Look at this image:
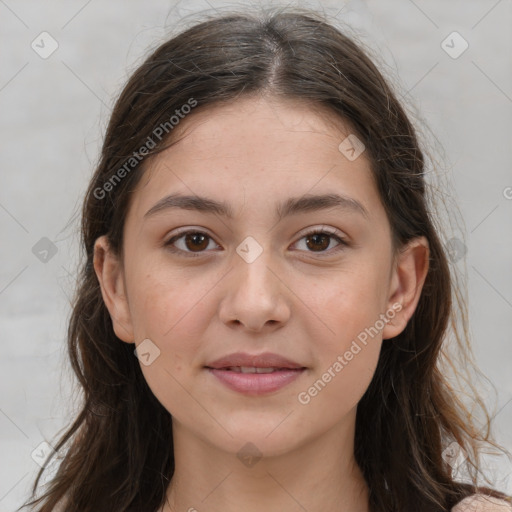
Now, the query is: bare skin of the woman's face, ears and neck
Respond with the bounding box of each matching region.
[95,97,428,512]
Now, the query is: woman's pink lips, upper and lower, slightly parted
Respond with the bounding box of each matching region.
[205,352,306,395]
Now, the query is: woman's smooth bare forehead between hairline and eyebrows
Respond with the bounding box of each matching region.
[128,97,379,224]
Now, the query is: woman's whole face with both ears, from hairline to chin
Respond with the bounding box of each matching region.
[95,94,426,455]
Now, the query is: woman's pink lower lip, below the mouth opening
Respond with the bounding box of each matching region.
[208,368,305,395]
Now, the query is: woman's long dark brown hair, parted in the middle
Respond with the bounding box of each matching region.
[20,9,503,512]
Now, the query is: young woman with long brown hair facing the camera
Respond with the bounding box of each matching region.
[21,5,512,512]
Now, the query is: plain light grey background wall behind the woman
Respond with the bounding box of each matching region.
[0,0,512,511]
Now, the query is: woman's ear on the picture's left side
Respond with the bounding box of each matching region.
[94,235,134,343]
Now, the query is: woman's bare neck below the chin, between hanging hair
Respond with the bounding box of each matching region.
[162,411,369,512]
